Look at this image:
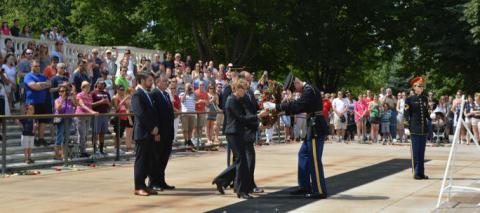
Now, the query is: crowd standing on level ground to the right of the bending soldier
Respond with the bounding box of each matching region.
[324,88,480,145]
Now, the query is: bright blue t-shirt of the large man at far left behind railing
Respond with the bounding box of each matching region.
[23,72,48,104]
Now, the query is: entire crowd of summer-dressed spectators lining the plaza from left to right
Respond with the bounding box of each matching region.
[0,20,480,163]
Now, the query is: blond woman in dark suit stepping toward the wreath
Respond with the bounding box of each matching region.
[224,79,268,199]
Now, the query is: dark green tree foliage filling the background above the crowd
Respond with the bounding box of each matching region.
[0,0,480,93]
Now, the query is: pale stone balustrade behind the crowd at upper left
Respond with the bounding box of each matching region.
[0,36,164,70]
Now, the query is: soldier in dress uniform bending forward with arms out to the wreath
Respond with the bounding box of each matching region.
[264,73,328,199]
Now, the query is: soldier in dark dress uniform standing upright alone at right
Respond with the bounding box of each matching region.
[404,76,430,180]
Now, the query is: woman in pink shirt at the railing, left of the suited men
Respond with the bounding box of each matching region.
[75,81,98,157]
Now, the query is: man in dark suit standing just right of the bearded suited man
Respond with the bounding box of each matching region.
[150,74,175,191]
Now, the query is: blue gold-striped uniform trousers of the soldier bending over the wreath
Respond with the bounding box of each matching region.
[298,134,327,194]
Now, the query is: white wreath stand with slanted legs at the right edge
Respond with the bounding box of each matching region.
[437,96,480,208]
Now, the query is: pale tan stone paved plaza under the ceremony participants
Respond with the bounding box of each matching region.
[0,144,480,213]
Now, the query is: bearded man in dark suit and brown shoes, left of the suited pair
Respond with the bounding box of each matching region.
[132,72,158,196]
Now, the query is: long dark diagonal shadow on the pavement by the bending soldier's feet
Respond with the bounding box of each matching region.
[208,159,412,212]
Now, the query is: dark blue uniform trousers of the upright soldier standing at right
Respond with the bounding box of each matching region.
[412,134,427,176]
